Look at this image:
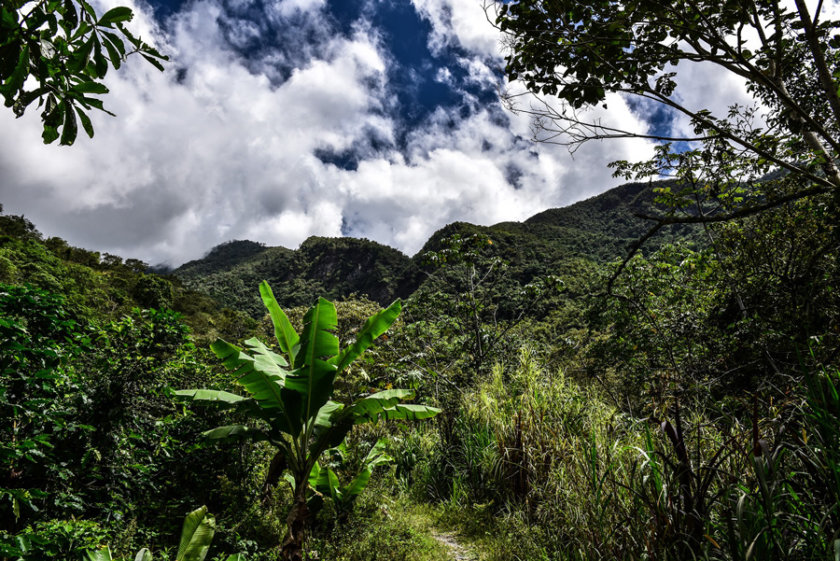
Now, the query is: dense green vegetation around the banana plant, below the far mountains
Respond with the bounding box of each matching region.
[0,165,840,560]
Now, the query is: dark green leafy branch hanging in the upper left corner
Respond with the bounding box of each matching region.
[0,0,169,145]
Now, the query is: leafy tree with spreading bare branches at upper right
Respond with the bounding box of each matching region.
[488,0,840,230]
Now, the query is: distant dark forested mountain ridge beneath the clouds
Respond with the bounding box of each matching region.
[172,183,696,317]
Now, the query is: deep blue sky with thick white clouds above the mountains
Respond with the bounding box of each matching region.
[0,0,756,266]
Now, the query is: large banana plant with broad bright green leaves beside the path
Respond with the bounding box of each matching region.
[175,281,440,561]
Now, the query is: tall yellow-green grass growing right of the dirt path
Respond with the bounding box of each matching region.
[412,350,840,561]
